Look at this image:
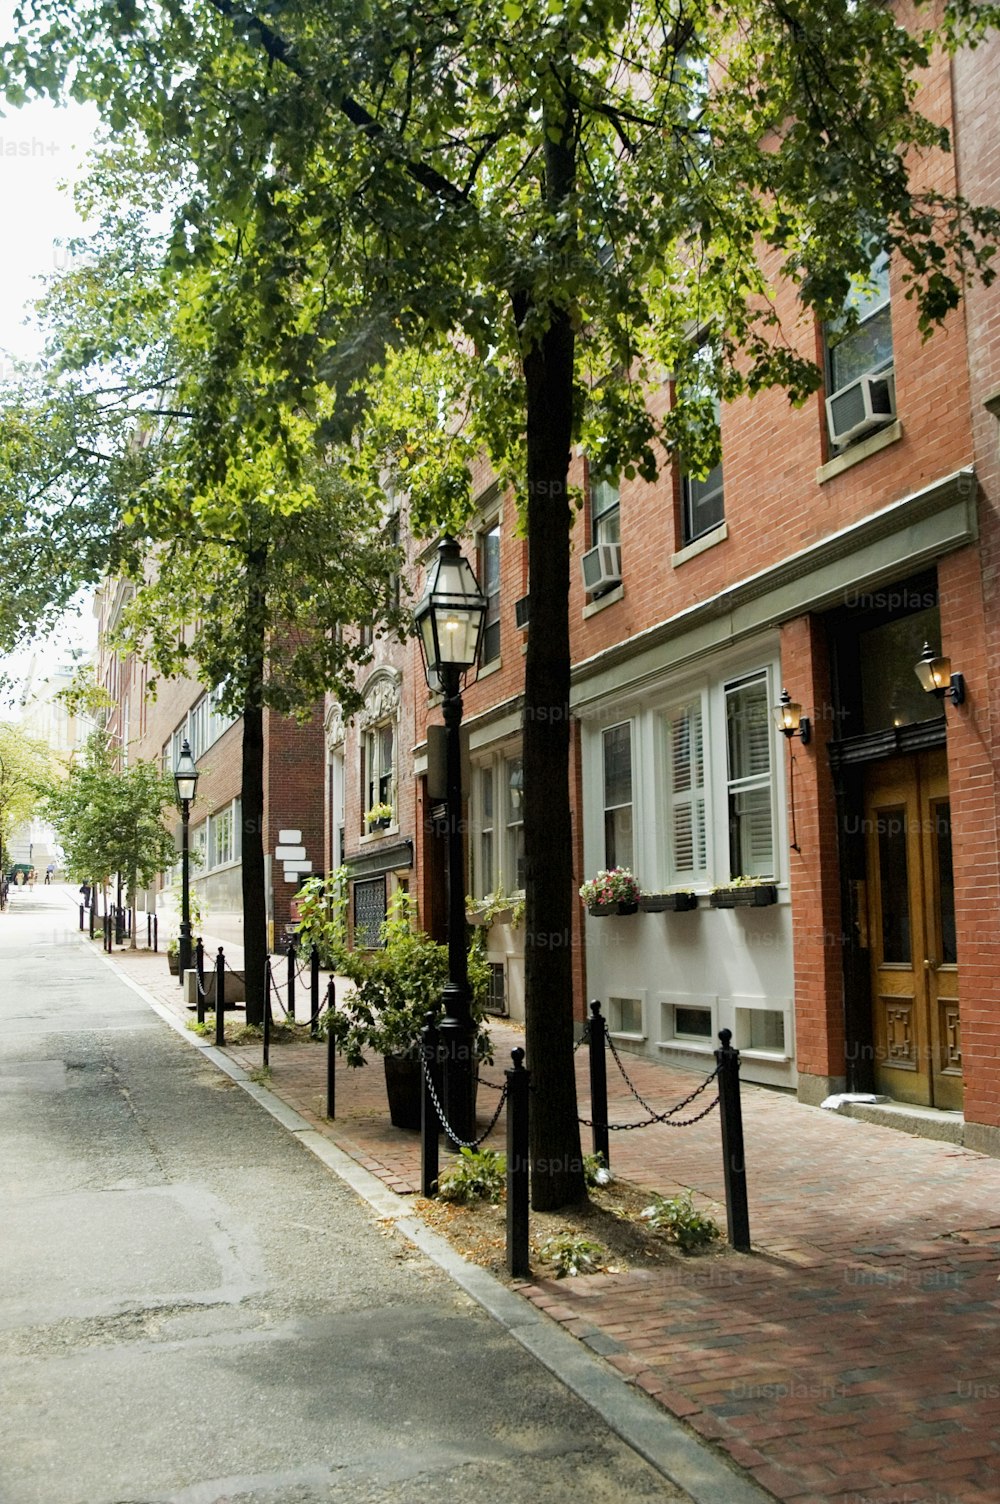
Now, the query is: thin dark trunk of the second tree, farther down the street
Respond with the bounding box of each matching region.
[242,547,268,1024]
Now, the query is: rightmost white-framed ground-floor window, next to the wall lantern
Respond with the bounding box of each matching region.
[725,674,774,877]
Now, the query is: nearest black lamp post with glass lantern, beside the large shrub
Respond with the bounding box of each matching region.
[414,535,487,1142]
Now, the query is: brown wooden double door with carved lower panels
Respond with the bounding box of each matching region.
[865,750,962,1110]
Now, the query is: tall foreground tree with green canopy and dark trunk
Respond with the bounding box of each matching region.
[3,0,998,1208]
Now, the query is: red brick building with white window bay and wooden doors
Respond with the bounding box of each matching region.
[328,23,1000,1152]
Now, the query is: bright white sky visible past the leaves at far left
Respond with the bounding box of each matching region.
[0,17,96,719]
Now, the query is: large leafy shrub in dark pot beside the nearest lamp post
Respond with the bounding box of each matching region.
[320,893,492,1128]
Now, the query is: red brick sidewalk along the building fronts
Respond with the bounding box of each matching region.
[103,920,1000,1504]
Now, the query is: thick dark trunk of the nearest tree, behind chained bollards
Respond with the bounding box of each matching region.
[514,103,586,1211]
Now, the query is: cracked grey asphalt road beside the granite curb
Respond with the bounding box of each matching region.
[0,886,687,1504]
